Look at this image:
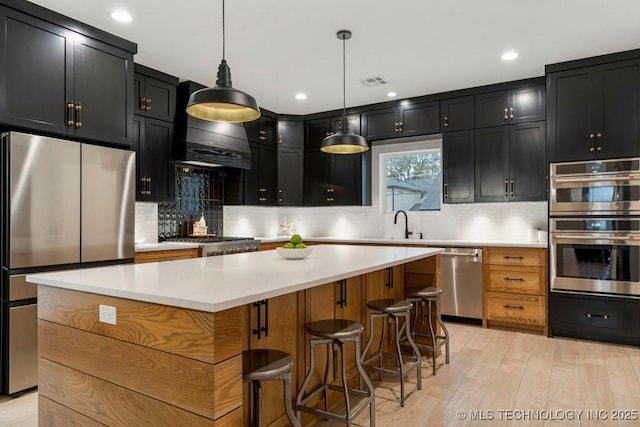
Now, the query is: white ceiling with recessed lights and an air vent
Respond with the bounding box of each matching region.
[32,0,640,114]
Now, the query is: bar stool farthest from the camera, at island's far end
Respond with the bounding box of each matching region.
[407,287,449,375]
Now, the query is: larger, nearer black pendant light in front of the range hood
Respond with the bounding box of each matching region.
[186,0,260,123]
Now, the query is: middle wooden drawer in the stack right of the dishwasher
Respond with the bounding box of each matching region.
[485,265,547,295]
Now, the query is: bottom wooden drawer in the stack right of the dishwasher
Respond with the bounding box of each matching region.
[485,292,546,326]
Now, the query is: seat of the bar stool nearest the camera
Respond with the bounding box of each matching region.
[242,349,293,382]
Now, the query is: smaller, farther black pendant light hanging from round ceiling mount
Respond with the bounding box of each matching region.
[320,30,369,154]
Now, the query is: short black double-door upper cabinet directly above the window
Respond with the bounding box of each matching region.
[362,101,440,141]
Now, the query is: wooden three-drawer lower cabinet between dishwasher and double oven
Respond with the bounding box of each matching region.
[482,248,547,334]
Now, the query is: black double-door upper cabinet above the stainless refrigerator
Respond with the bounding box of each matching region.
[0,7,137,145]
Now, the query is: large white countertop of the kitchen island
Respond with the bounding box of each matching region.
[27,245,442,312]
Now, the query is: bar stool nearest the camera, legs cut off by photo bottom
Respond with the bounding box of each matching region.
[242,349,301,427]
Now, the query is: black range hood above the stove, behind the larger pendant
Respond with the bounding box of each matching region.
[173,81,251,169]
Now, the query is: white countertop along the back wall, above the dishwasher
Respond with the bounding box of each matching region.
[255,236,549,248]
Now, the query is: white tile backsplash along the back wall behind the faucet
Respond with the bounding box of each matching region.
[224,202,547,241]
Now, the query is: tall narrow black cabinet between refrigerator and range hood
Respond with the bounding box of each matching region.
[133,64,178,202]
